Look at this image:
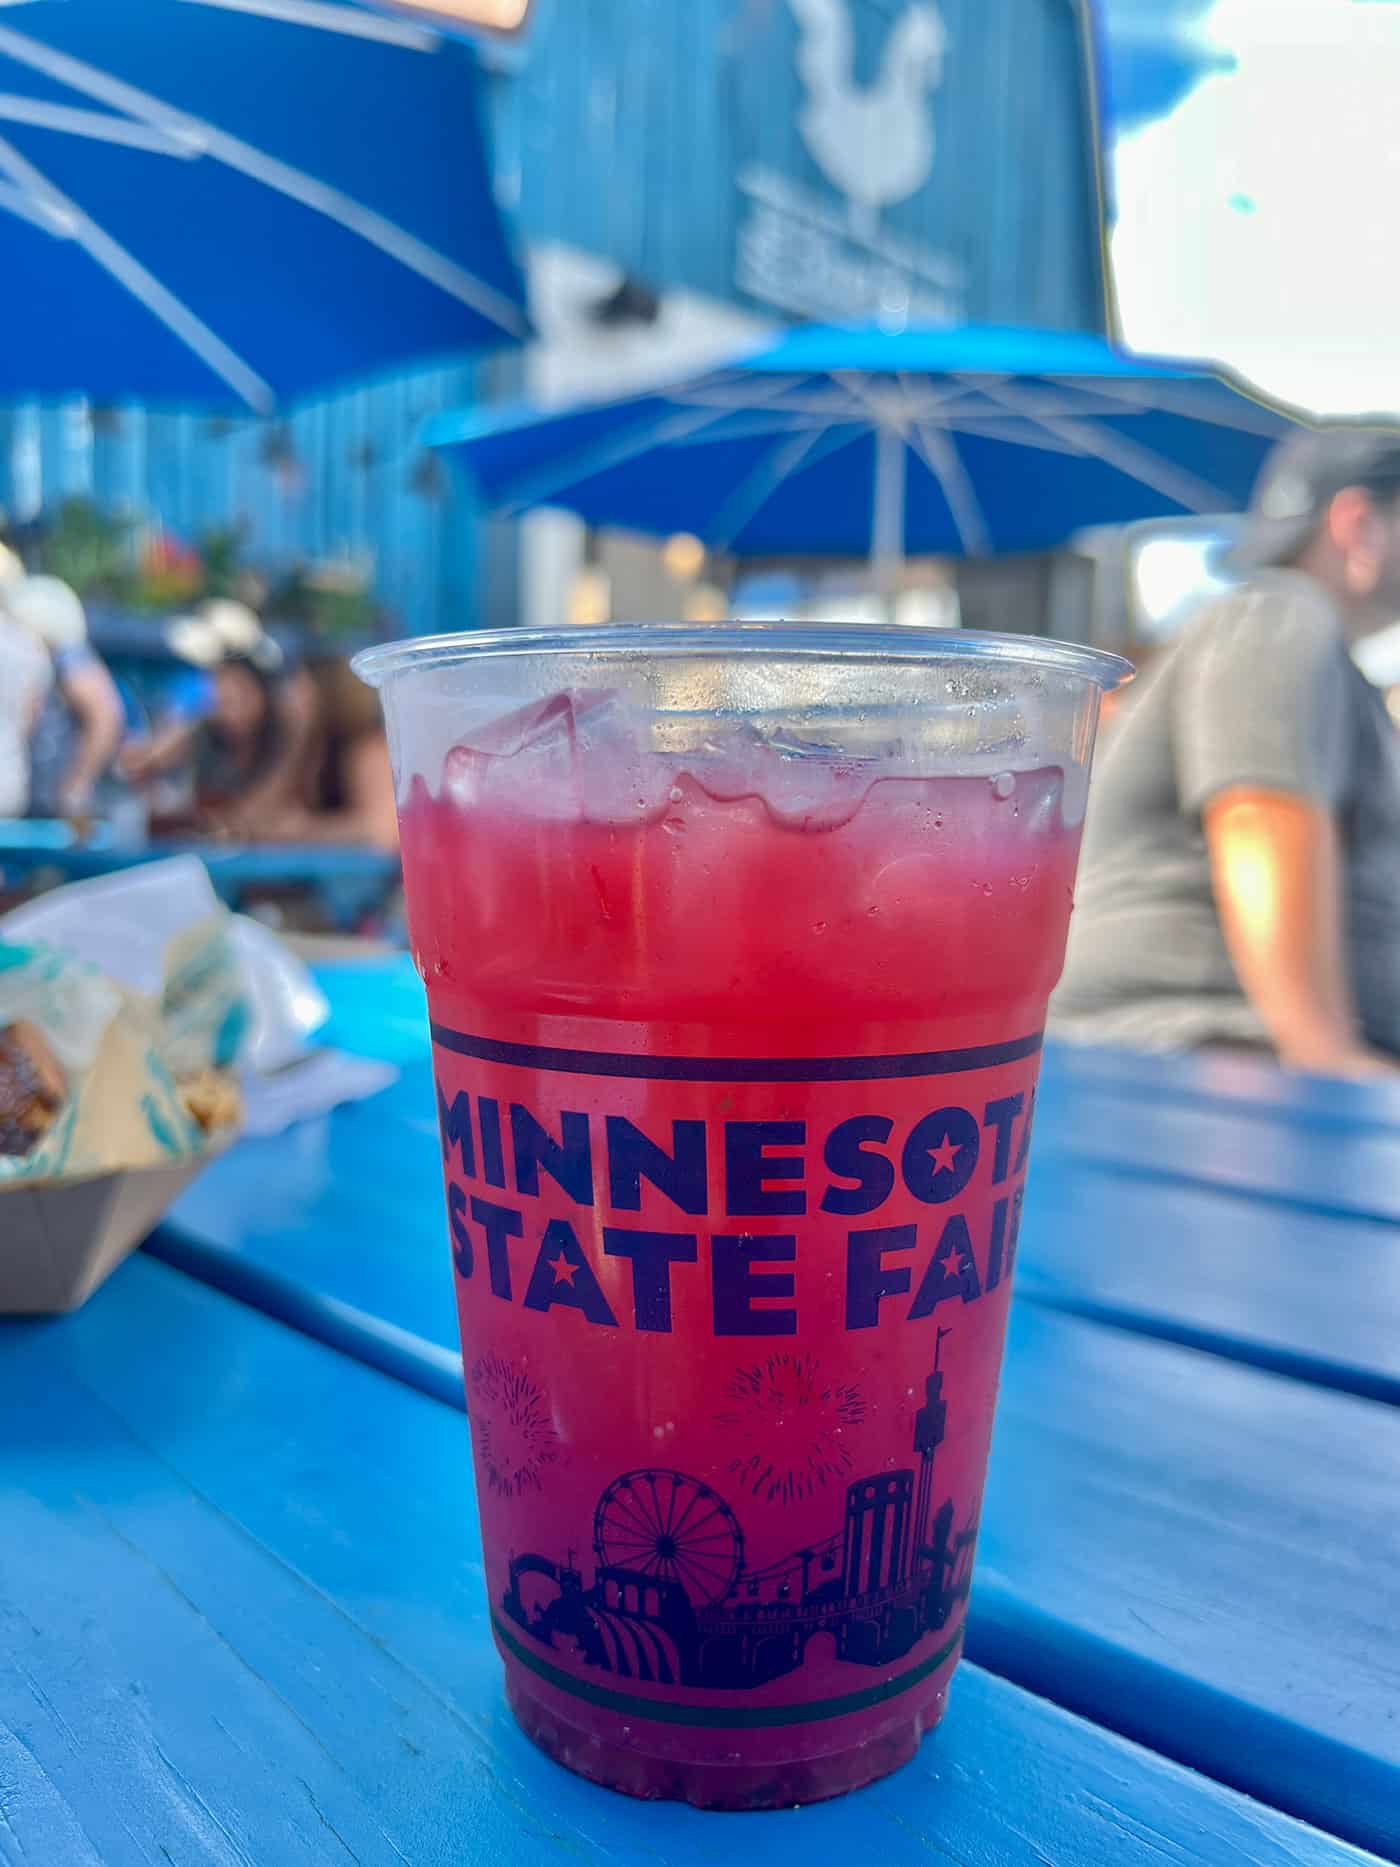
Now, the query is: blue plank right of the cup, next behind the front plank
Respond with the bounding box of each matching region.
[969,1303,1400,1860]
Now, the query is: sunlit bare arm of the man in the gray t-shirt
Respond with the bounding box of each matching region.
[1204,786,1394,1075]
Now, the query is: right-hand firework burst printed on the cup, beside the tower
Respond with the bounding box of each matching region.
[715,1350,866,1505]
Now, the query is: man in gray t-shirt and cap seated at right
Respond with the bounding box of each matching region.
[1051,426,1400,1075]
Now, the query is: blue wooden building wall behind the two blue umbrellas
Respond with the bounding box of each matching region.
[0,0,1105,633]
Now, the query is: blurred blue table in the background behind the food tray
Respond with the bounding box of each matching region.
[0,820,399,930]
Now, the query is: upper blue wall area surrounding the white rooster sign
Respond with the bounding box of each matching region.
[495,0,1105,330]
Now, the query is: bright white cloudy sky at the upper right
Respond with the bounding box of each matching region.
[1109,0,1400,414]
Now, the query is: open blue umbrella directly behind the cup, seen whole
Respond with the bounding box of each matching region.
[427,327,1292,573]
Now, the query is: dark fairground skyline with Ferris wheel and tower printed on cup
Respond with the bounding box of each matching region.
[502,1354,976,1690]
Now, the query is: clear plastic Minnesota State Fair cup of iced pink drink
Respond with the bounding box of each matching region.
[357,624,1127,1807]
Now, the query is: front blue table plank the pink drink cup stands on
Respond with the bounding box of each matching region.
[0,1258,1388,1867]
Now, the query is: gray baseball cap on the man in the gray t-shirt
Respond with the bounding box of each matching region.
[1228,422,1400,569]
